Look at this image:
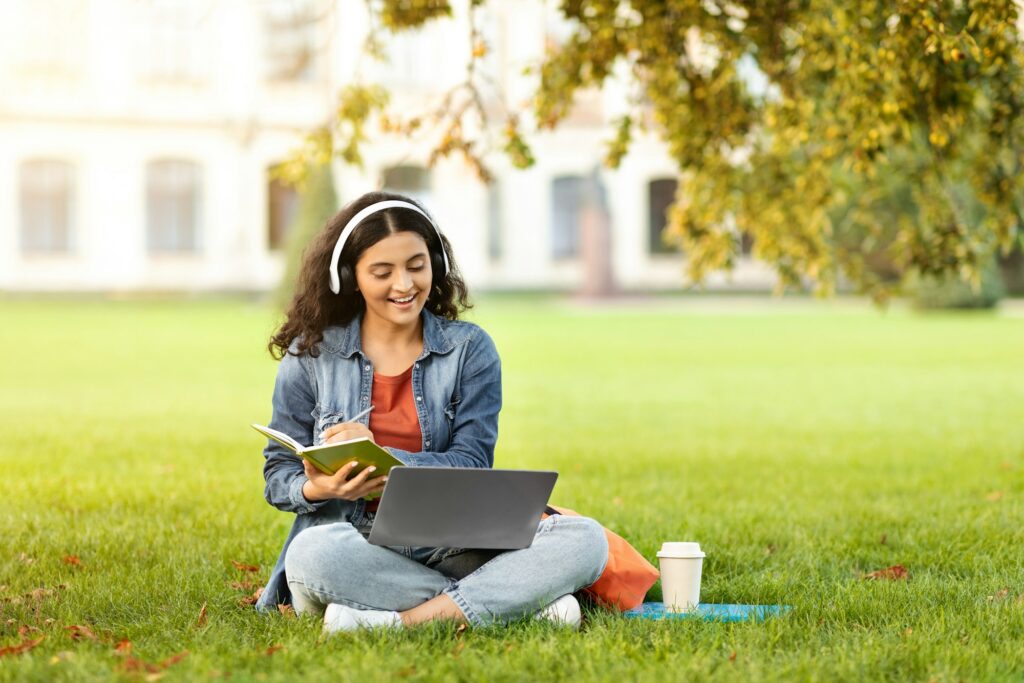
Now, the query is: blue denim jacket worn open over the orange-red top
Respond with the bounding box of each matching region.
[256,308,502,611]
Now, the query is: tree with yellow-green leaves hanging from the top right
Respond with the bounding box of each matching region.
[282,0,1024,300]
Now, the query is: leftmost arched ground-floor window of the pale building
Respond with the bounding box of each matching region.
[18,160,75,254]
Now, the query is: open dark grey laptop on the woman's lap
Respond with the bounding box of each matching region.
[368,467,558,550]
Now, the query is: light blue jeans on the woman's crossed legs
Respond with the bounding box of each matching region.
[285,505,608,626]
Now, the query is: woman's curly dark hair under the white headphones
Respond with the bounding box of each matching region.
[267,187,472,359]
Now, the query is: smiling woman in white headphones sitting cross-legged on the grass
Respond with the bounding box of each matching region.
[256,193,607,632]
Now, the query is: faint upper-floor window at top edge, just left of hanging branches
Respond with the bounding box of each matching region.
[263,0,328,81]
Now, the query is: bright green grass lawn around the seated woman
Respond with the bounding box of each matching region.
[0,298,1024,681]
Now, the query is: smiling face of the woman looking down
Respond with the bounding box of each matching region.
[355,230,433,326]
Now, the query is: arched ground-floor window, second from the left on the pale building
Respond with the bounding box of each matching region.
[145,160,202,253]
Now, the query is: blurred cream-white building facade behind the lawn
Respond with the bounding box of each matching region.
[0,0,773,291]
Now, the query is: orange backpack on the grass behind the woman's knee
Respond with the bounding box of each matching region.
[541,505,659,611]
